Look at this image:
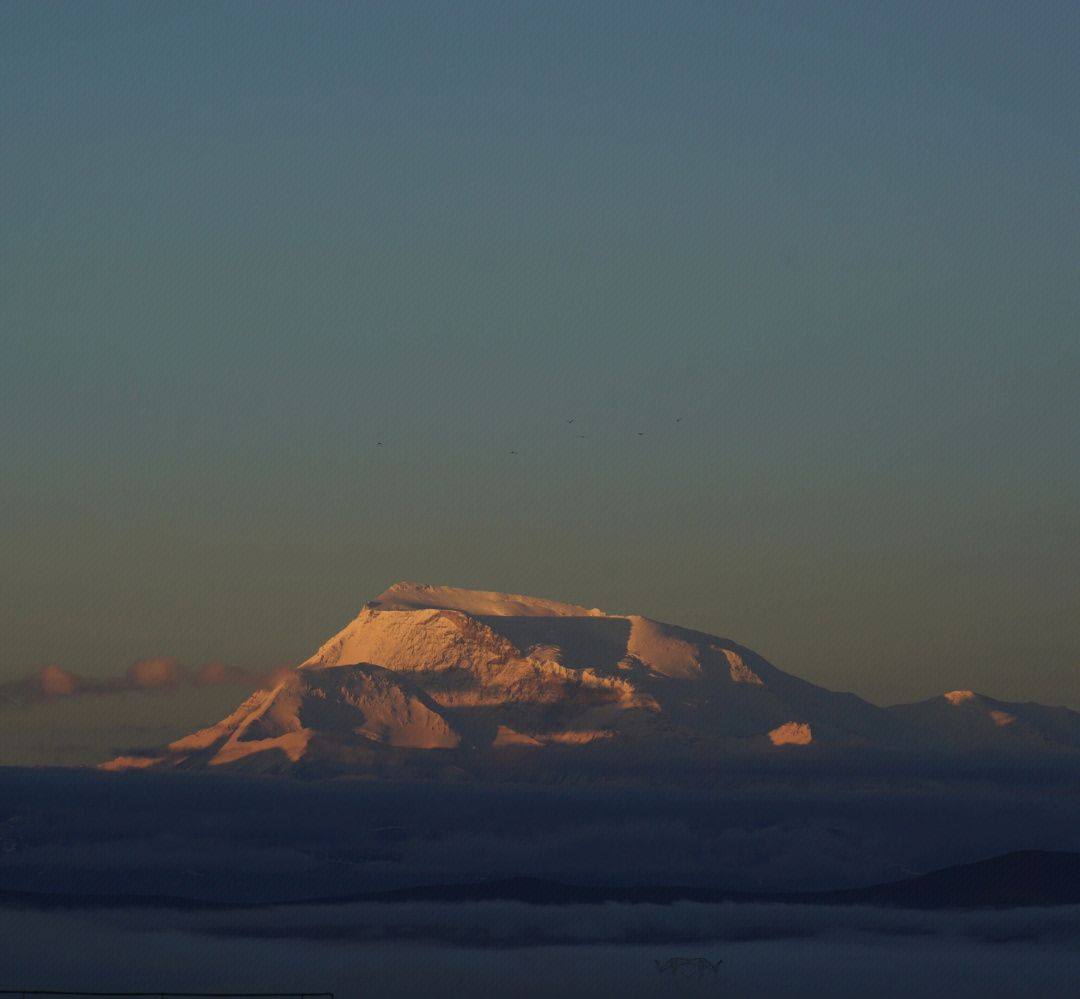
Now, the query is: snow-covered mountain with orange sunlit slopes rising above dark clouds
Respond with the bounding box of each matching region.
[103,583,1080,777]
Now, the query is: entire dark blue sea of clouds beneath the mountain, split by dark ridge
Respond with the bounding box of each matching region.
[6,760,1080,999]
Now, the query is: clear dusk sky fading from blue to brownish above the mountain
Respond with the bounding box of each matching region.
[0,0,1080,725]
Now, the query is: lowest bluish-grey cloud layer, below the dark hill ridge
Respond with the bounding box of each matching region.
[0,904,1080,999]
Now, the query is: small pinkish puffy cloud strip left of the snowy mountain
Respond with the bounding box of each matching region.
[0,656,293,706]
